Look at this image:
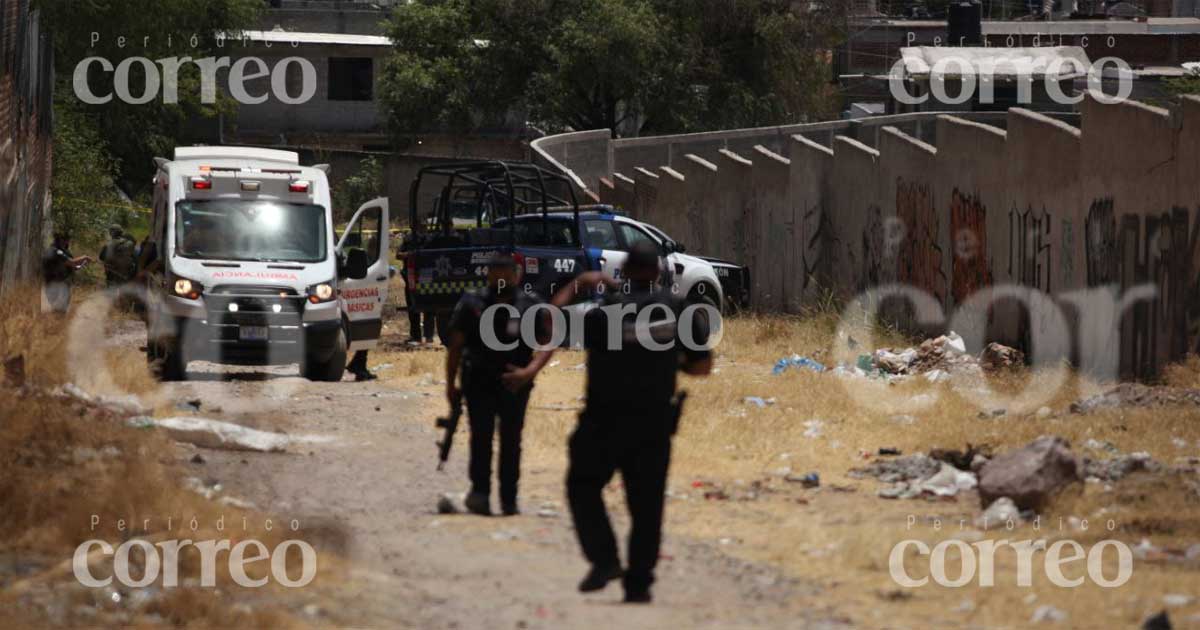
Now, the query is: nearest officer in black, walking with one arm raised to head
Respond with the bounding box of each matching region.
[552,241,713,602]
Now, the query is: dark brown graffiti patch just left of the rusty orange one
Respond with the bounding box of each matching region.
[902,178,946,302]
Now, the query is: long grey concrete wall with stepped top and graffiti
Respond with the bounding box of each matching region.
[540,97,1200,378]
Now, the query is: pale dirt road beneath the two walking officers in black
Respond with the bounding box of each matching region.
[152,350,839,628]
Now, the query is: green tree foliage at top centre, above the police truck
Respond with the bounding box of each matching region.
[382,0,840,134]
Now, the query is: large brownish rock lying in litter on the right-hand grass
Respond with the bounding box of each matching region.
[979,436,1082,510]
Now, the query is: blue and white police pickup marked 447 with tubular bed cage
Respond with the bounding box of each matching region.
[401,162,748,338]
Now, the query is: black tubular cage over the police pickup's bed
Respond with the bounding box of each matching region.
[408,160,580,245]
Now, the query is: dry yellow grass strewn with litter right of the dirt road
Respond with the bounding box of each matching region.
[379,313,1200,628]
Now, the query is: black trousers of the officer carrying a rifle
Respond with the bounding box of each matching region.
[466,379,532,505]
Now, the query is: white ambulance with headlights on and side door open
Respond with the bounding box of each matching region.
[138,146,389,380]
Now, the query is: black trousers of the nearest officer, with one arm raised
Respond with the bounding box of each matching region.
[566,410,671,592]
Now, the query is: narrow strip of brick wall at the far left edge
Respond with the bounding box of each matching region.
[0,0,54,292]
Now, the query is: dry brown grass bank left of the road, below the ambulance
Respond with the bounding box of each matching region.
[0,283,355,628]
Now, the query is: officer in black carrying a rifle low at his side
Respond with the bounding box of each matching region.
[446,253,552,516]
